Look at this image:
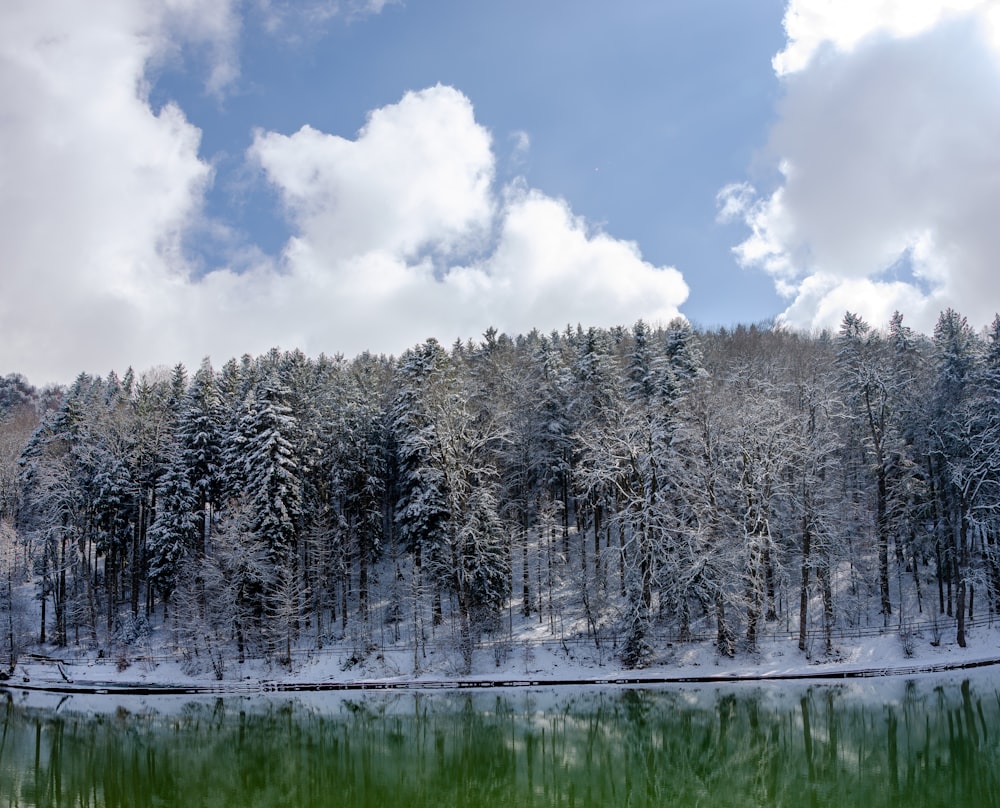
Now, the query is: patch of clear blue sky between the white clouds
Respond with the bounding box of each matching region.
[152,0,784,326]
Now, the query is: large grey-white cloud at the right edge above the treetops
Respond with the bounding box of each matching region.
[719,0,1000,330]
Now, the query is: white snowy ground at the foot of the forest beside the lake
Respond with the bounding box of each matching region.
[6,621,1000,693]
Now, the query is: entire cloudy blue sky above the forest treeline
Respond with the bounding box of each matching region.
[0,0,1000,384]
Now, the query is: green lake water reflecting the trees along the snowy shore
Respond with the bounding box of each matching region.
[0,674,1000,808]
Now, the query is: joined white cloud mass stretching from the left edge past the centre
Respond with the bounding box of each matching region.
[0,0,687,383]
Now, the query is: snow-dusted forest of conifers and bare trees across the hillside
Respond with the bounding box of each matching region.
[0,310,1000,678]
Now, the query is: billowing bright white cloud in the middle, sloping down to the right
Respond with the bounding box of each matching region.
[251,86,687,352]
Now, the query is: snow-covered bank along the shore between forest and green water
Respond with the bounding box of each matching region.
[0,625,1000,695]
